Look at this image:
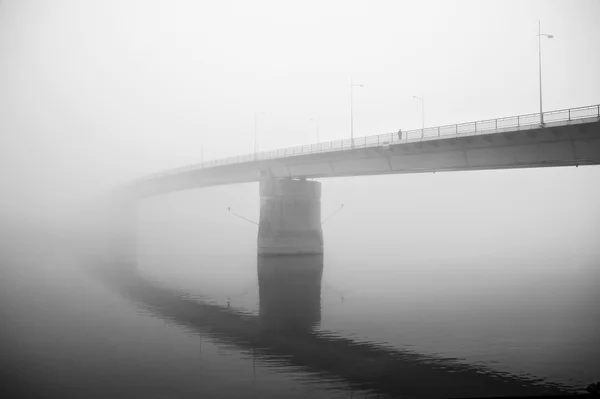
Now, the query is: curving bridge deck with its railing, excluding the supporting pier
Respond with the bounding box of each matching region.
[126,105,600,198]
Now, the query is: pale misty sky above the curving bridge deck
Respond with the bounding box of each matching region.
[0,0,600,225]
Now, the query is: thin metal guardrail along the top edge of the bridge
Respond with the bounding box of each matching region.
[138,104,600,181]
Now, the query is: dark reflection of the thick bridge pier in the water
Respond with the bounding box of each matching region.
[258,254,323,331]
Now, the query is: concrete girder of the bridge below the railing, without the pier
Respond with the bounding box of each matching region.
[131,118,600,198]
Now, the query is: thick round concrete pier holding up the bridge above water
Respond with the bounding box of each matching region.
[258,178,323,256]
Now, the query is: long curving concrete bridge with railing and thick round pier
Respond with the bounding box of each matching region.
[114,105,600,256]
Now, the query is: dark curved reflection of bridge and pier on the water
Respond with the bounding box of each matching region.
[88,256,570,398]
